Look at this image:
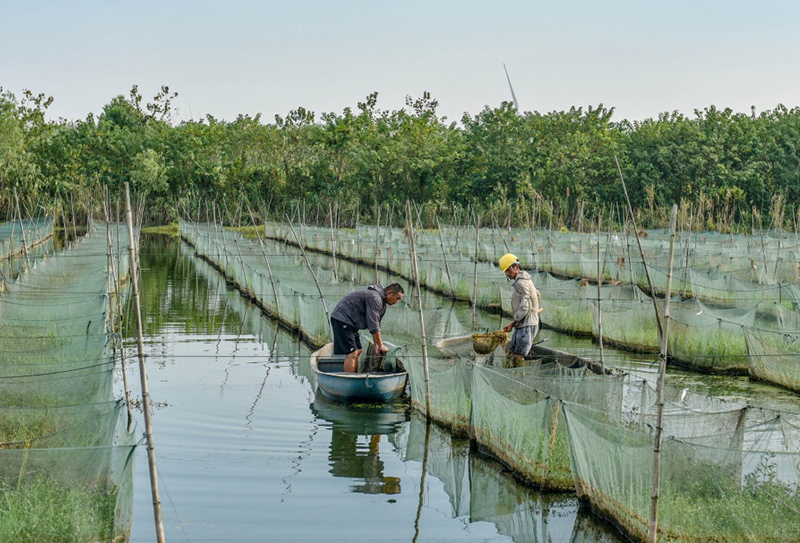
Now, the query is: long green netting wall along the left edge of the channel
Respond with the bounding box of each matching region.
[0,223,136,541]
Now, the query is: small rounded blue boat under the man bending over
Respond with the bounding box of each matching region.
[311,343,408,402]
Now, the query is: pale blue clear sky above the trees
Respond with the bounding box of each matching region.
[0,0,800,122]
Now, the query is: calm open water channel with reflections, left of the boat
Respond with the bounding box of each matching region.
[128,236,621,543]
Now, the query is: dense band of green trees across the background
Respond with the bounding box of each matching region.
[0,86,800,229]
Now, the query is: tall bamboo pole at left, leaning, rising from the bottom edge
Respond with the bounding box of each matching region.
[125,181,165,543]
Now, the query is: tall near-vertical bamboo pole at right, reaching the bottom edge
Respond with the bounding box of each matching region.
[648,204,678,543]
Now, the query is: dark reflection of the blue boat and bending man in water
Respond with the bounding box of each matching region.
[311,389,409,494]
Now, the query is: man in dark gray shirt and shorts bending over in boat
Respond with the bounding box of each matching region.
[331,283,404,373]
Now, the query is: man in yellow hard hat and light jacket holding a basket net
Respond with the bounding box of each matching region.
[500,253,542,366]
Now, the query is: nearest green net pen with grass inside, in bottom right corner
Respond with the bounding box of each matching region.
[564,404,800,541]
